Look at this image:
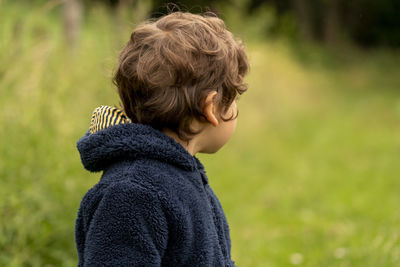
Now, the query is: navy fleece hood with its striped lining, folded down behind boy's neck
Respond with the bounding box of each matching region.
[77,106,204,172]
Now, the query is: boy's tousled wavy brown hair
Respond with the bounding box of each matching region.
[113,12,248,148]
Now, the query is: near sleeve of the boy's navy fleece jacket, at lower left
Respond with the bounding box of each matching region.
[76,172,168,266]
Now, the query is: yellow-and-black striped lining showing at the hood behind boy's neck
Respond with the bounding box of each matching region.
[89,106,131,134]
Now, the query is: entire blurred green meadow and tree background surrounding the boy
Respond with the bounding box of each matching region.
[0,0,400,267]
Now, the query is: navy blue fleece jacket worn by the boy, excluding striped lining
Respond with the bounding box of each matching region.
[75,115,234,266]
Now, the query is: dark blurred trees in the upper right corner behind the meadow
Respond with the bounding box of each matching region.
[247,0,400,47]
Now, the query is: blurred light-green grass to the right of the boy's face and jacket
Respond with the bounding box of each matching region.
[204,45,400,266]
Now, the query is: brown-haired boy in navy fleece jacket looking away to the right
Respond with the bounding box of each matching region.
[75,12,248,266]
